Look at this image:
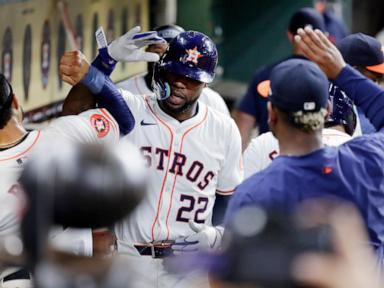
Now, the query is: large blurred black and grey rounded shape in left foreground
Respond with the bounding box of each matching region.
[20,139,146,228]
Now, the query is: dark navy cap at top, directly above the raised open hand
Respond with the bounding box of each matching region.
[288,7,325,35]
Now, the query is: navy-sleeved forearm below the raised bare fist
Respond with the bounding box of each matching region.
[82,65,135,135]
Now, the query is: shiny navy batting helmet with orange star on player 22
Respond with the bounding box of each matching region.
[153,31,218,100]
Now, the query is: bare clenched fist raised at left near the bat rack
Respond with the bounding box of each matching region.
[60,50,89,86]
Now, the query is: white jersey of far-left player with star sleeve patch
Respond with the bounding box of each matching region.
[0,109,120,255]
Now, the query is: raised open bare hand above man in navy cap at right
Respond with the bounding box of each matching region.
[295,27,346,79]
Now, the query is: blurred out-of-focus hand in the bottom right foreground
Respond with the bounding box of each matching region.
[293,206,384,288]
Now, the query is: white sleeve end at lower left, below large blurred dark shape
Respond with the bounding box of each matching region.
[49,228,93,257]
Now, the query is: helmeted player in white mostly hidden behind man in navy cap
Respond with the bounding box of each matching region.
[243,82,356,178]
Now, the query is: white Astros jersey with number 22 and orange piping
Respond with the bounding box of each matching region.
[115,91,242,255]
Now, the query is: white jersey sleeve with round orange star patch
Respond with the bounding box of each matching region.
[44,109,120,143]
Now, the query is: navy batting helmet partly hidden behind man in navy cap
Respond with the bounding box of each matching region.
[325,84,357,135]
